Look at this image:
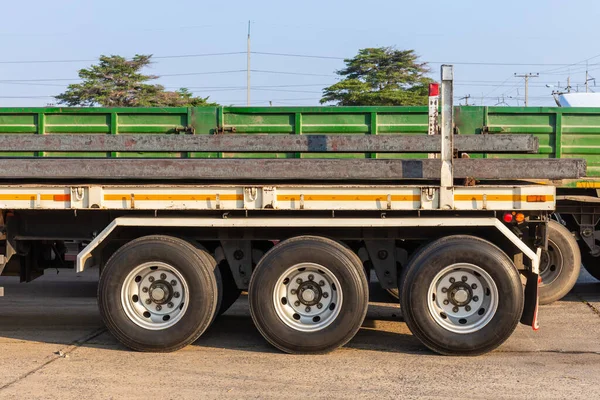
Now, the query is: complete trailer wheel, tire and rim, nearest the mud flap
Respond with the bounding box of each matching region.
[400,235,524,355]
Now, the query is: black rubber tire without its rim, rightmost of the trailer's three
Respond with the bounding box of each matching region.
[400,235,524,356]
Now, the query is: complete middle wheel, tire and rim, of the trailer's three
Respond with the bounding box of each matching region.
[248,236,369,353]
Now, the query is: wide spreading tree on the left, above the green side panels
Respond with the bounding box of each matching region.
[56,54,216,107]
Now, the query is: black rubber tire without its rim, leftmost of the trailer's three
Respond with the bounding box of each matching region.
[98,235,219,352]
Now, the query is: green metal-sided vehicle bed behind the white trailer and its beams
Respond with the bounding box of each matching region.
[0,106,600,296]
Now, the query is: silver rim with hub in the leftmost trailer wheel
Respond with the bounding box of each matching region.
[121,262,189,330]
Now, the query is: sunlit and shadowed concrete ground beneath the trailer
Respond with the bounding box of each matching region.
[0,270,600,399]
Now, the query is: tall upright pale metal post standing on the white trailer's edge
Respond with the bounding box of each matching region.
[440,65,454,210]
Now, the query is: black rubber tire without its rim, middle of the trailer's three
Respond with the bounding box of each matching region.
[248,236,369,354]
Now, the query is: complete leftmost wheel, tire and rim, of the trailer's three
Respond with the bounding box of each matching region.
[98,235,219,352]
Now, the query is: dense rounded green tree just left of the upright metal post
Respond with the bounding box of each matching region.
[321,47,433,106]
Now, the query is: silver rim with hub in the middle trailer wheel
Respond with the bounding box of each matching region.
[273,263,343,332]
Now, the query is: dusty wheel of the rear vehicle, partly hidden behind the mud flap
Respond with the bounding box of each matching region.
[540,221,581,304]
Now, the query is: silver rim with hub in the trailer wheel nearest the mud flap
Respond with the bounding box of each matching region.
[428,263,498,333]
